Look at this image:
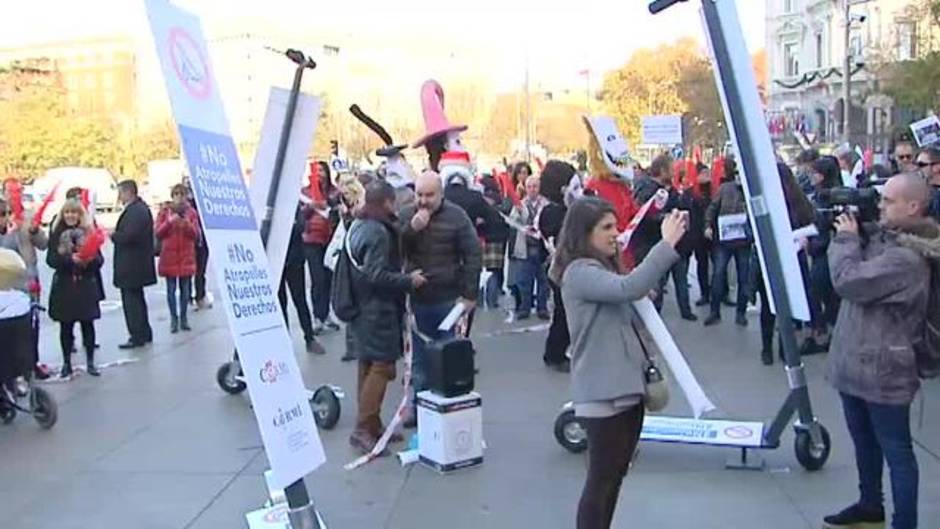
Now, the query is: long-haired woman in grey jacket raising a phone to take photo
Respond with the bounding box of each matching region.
[551,197,688,529]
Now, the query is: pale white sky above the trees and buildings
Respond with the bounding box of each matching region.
[0,0,765,89]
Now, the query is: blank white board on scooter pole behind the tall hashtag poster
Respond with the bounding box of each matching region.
[248,88,320,290]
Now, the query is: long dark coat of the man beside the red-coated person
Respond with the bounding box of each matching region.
[111,198,157,288]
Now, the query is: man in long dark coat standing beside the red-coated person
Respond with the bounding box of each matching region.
[111,180,157,349]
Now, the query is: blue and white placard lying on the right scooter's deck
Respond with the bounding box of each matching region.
[640,415,764,448]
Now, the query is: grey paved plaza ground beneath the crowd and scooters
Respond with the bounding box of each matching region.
[0,254,940,529]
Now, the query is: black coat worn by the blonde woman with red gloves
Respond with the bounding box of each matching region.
[46,222,104,322]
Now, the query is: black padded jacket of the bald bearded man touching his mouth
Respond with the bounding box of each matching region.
[401,200,483,305]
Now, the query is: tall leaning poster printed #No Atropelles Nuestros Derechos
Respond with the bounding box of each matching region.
[145,0,326,488]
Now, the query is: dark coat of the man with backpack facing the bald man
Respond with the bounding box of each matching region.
[346,220,411,362]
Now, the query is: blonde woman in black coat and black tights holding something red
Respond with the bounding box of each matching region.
[46,198,104,378]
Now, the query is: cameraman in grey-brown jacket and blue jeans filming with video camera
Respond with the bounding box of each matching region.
[825,173,940,529]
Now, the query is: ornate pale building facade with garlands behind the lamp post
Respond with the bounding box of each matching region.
[766,0,924,152]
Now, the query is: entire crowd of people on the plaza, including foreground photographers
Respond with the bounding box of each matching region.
[0,137,940,529]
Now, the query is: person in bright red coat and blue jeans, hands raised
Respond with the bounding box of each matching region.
[156,184,199,333]
